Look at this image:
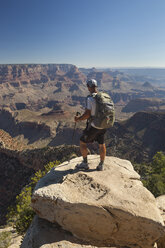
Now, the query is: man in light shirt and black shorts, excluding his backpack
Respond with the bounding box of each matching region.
[75,79,106,171]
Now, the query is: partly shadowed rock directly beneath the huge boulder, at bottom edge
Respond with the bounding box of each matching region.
[21,216,115,248]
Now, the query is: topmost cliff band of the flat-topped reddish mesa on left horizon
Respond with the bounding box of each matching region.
[0,64,84,85]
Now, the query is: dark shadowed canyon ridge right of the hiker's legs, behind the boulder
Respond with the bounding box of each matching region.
[106,112,165,163]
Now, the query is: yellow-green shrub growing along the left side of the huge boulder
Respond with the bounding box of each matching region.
[7,161,60,235]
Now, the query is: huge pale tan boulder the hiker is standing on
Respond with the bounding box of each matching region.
[32,155,165,248]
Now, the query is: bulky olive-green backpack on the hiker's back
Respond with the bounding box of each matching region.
[92,92,115,128]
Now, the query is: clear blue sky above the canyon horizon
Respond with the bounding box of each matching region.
[0,0,165,67]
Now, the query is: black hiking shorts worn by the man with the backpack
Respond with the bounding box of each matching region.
[80,126,106,145]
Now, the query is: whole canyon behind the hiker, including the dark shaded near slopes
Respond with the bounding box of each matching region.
[0,64,165,229]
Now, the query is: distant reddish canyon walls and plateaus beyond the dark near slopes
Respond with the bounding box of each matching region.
[0,64,165,148]
